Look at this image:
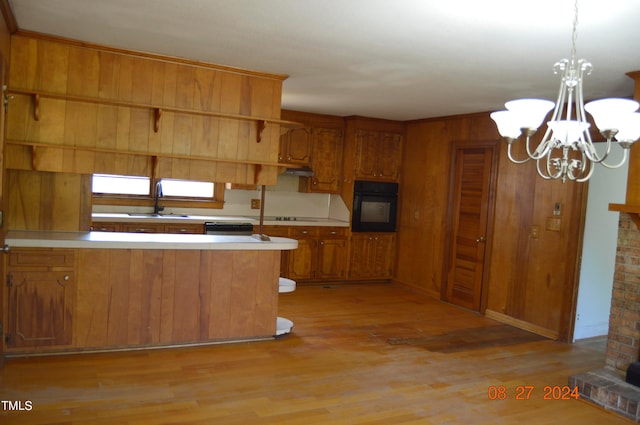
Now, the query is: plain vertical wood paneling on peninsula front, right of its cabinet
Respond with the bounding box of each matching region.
[73,249,280,349]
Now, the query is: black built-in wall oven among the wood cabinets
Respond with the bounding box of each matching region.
[351,180,398,232]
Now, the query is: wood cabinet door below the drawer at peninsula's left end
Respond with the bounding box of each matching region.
[7,271,75,348]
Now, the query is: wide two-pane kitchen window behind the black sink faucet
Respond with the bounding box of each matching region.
[91,174,224,208]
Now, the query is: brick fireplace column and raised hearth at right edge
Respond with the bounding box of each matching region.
[569,212,640,422]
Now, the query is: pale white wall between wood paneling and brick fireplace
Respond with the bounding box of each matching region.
[567,157,628,341]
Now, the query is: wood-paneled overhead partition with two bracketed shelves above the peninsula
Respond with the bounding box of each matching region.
[7,35,284,184]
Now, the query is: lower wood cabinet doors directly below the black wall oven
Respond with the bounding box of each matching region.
[349,233,396,280]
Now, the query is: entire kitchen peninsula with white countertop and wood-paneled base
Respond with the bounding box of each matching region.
[5,231,297,356]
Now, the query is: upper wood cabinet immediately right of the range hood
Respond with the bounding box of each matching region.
[300,128,343,193]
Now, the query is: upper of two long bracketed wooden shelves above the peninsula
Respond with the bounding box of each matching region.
[6,88,304,143]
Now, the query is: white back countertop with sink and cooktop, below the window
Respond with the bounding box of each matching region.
[91,213,349,227]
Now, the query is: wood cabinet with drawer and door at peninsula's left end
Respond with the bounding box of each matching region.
[5,248,76,351]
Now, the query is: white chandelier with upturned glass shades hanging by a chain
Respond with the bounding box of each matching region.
[491,0,640,182]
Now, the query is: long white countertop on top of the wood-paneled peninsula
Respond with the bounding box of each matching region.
[5,230,298,251]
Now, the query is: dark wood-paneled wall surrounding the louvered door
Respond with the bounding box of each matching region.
[397,114,585,339]
